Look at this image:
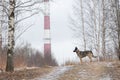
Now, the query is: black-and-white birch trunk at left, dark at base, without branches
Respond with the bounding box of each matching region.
[6,0,15,72]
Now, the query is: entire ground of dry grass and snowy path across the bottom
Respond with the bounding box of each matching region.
[0,62,120,80]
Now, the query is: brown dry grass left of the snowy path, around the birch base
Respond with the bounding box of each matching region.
[0,67,53,80]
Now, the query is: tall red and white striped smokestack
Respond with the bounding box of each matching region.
[44,0,51,56]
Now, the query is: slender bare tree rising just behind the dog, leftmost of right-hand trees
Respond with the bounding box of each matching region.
[70,0,87,50]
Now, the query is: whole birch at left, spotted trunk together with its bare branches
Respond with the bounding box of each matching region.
[0,0,43,72]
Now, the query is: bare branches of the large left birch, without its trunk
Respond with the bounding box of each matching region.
[0,0,44,41]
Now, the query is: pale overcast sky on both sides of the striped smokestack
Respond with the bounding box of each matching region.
[20,0,77,64]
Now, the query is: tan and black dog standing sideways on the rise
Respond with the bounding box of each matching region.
[73,47,97,63]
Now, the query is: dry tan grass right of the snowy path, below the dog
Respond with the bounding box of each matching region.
[58,62,120,80]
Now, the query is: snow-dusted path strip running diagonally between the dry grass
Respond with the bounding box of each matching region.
[33,66,72,80]
